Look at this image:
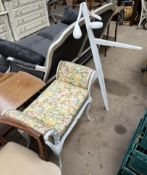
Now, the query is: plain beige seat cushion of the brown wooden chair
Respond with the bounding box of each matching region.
[0,142,61,175]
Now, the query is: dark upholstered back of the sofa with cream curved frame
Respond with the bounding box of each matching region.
[44,3,115,80]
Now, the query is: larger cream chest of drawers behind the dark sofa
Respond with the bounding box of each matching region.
[4,0,49,41]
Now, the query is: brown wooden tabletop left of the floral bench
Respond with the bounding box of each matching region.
[0,72,45,113]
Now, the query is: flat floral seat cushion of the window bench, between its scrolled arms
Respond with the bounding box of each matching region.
[23,80,88,134]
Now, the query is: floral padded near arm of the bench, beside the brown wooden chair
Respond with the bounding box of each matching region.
[4,110,48,134]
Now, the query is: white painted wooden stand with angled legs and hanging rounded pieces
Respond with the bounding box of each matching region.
[73,2,142,110]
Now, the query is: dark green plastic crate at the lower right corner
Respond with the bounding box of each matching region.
[118,111,147,175]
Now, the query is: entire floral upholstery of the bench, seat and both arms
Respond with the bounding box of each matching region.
[5,61,93,136]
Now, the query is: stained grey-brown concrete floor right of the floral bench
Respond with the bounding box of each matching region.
[58,24,147,175]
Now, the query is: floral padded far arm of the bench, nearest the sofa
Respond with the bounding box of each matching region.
[57,61,93,89]
